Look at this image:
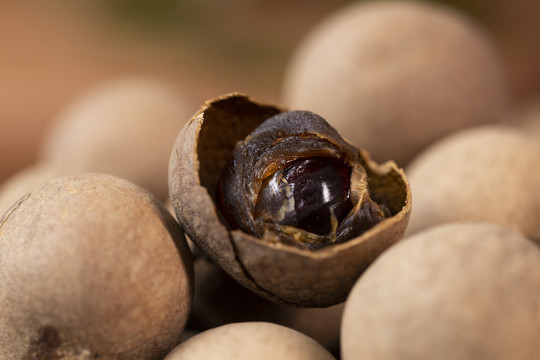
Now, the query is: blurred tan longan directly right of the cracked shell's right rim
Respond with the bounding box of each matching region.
[407,125,540,240]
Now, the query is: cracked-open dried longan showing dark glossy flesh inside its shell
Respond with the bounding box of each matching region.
[169,93,411,307]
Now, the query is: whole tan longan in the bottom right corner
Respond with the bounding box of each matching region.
[341,223,540,360]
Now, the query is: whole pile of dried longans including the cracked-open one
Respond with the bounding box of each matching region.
[0,1,540,360]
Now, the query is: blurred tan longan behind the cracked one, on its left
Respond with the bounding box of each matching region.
[40,77,196,200]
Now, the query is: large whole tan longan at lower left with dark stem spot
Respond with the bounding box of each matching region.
[0,174,193,360]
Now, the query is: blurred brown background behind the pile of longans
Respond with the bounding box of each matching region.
[0,0,540,181]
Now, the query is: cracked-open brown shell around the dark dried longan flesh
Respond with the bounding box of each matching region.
[169,94,411,307]
